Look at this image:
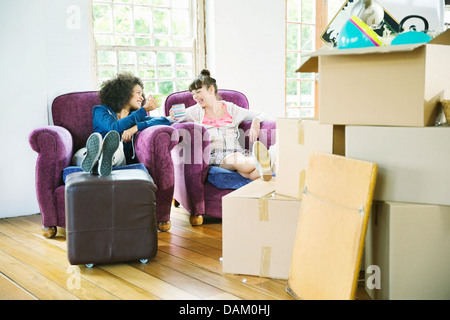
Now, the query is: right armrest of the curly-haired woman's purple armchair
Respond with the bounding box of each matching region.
[134,125,179,222]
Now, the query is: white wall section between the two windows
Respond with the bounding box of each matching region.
[206,0,286,117]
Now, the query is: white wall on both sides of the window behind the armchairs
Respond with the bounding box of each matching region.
[0,0,285,218]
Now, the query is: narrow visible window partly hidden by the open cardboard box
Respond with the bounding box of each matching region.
[286,0,345,117]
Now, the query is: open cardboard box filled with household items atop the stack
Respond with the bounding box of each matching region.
[297,30,450,127]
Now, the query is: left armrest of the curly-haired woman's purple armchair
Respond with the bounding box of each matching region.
[28,126,73,220]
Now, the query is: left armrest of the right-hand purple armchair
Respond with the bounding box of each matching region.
[172,122,210,215]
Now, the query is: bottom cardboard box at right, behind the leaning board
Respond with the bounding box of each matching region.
[365,202,450,300]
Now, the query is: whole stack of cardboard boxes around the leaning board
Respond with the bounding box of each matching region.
[223,30,450,299]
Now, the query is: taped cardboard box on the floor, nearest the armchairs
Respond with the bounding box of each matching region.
[222,179,301,279]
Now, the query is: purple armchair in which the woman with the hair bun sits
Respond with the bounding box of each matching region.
[164,89,276,225]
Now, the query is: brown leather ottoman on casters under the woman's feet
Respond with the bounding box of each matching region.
[65,169,158,267]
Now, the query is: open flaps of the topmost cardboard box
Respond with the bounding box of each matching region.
[296,29,450,72]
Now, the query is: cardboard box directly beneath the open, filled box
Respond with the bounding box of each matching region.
[345,126,450,205]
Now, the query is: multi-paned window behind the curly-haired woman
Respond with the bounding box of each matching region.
[92,0,205,114]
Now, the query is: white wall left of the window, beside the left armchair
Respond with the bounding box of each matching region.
[0,0,92,218]
